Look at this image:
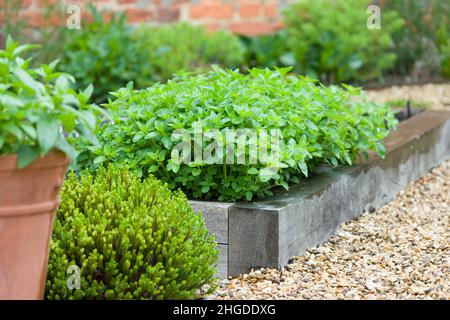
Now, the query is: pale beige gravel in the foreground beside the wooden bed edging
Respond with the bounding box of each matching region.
[212,160,450,299]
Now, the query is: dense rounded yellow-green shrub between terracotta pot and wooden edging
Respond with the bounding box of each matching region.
[46,167,217,299]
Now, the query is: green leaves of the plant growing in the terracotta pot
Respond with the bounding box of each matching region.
[0,37,96,168]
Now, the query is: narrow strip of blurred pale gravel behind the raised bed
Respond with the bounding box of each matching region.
[367,83,450,109]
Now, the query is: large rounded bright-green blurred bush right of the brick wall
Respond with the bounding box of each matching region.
[285,0,402,83]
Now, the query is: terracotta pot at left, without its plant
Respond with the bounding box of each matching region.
[0,152,69,300]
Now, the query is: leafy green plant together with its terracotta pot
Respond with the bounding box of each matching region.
[0,37,99,299]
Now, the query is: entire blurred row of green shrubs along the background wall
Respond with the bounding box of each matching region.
[3,0,450,103]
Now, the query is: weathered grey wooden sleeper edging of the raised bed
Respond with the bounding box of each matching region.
[190,110,450,276]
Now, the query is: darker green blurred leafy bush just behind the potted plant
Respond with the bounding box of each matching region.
[60,7,154,103]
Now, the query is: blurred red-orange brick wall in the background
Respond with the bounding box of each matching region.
[0,0,298,35]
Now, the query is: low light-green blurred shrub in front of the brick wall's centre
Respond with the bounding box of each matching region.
[135,23,244,80]
